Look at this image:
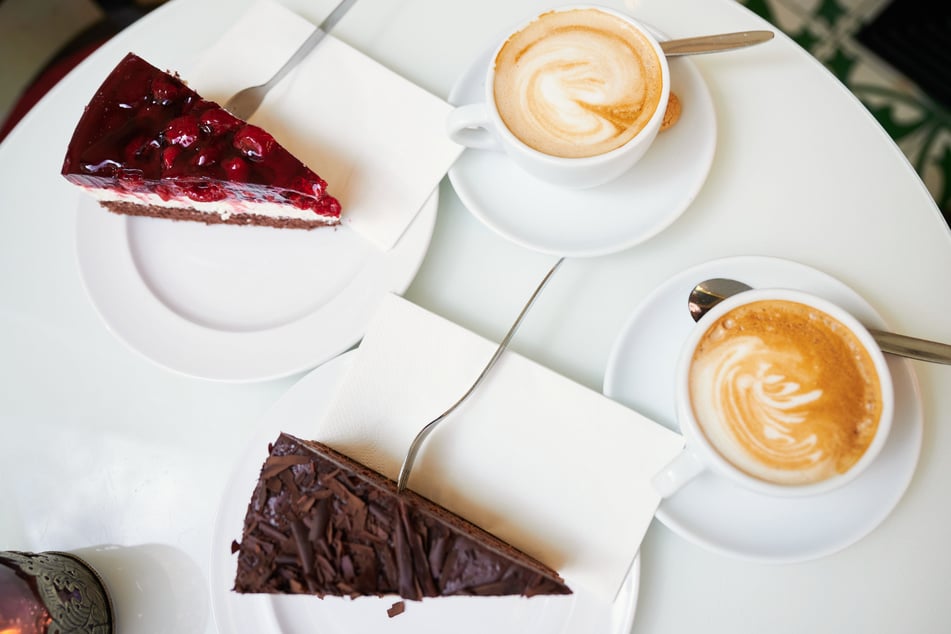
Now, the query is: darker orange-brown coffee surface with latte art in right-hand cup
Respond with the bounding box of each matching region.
[689,300,883,485]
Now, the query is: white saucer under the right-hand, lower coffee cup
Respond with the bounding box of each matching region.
[603,256,924,563]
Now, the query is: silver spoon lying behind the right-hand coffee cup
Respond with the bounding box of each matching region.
[687,277,951,365]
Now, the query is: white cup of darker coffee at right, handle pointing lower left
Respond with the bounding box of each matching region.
[653,289,894,497]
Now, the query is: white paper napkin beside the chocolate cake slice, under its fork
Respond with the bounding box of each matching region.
[315,295,683,602]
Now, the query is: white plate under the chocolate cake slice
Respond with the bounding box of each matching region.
[211,353,640,634]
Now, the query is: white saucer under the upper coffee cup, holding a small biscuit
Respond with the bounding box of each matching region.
[449,32,716,257]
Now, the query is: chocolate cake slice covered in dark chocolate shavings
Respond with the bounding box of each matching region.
[234,434,571,600]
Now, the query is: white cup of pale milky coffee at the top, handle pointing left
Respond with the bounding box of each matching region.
[447,5,670,188]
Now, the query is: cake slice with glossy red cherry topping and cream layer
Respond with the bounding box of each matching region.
[62,53,340,229]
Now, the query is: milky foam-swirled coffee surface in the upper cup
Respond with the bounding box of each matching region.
[493,9,664,158]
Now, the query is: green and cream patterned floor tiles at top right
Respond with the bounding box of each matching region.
[738,0,951,224]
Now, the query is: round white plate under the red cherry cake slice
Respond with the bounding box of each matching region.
[76,191,438,382]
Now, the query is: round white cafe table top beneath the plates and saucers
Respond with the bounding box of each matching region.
[0,0,951,634]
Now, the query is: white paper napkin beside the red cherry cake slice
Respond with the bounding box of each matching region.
[183,1,462,250]
